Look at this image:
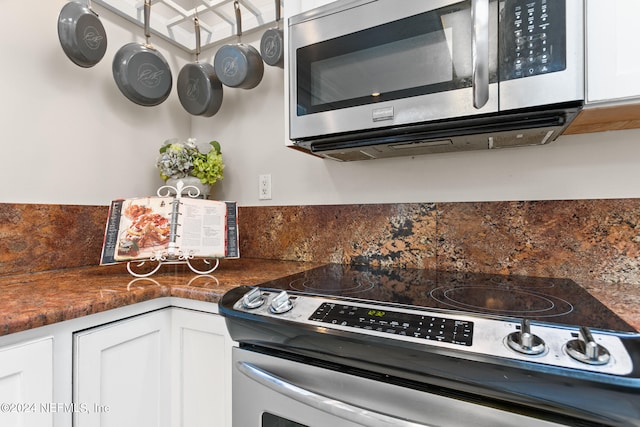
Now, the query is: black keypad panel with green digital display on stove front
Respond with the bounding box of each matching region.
[309,303,473,346]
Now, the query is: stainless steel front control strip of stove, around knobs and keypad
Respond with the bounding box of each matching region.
[233,291,633,375]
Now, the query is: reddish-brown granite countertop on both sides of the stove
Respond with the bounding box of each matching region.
[0,258,640,336]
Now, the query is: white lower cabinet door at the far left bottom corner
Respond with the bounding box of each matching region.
[0,338,53,427]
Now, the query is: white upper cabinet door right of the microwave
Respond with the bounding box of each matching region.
[586,0,640,102]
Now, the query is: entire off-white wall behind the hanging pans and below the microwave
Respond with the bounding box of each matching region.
[0,0,640,206]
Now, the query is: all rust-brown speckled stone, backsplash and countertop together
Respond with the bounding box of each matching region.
[0,199,640,333]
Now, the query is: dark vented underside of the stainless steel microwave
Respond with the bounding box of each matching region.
[295,103,582,162]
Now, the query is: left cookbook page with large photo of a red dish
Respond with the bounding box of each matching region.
[114,197,174,261]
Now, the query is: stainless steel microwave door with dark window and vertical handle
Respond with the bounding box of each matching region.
[289,0,498,140]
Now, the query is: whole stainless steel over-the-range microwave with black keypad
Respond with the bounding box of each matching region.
[288,0,584,161]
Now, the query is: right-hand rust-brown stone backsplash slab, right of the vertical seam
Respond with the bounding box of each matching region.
[437,199,640,284]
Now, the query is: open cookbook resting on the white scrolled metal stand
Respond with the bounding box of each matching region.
[100,196,240,265]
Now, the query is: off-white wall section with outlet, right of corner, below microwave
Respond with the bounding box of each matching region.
[198,67,640,206]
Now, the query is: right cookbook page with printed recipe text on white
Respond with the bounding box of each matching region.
[176,198,227,258]
